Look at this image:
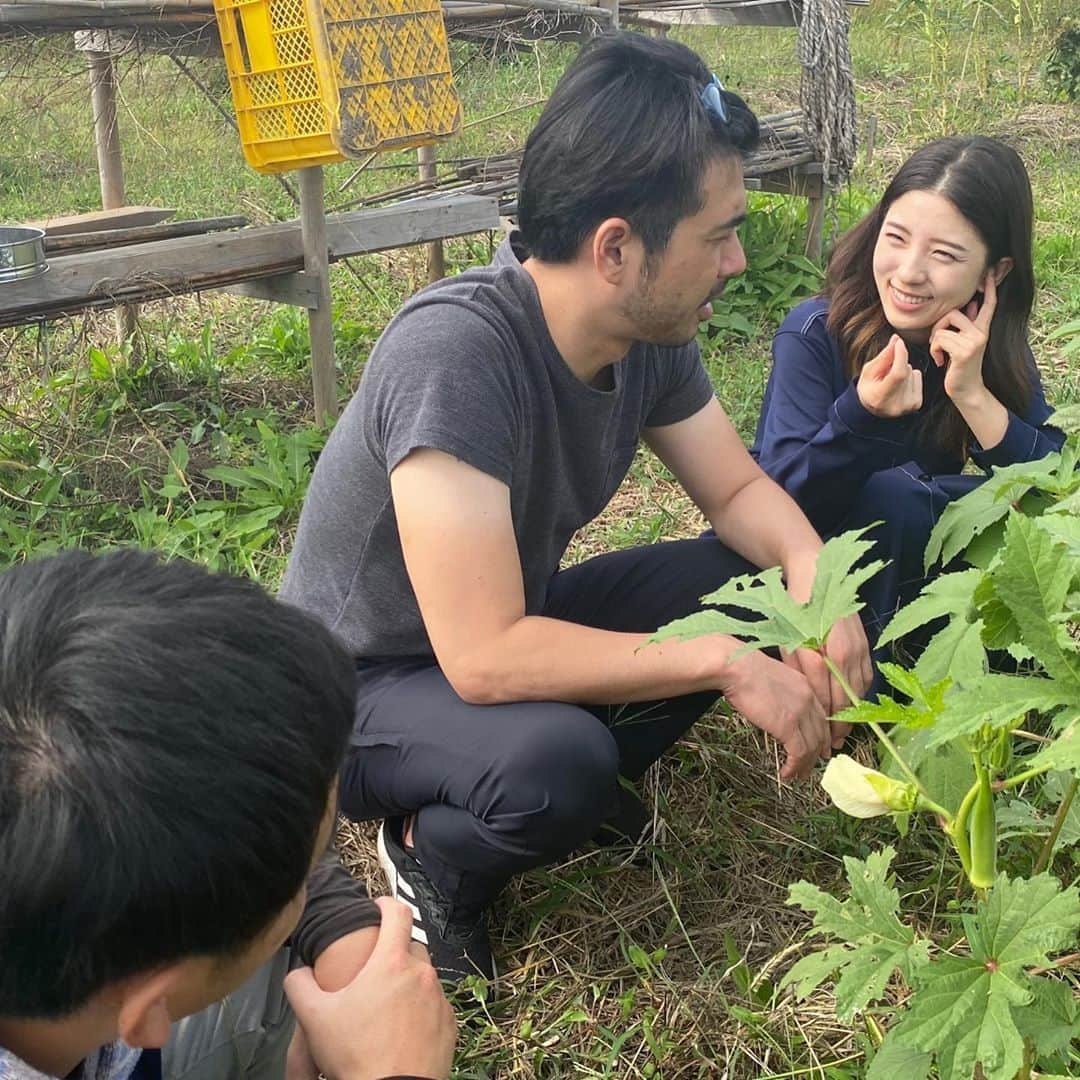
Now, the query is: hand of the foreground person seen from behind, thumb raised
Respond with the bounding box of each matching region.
[285,896,456,1080]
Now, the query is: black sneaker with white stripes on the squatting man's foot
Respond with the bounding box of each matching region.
[378,818,496,985]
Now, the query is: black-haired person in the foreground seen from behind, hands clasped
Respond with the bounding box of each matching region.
[0,550,454,1080]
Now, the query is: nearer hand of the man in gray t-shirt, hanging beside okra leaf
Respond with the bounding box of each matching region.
[720,652,832,780]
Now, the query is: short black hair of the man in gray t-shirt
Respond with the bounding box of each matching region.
[517,32,758,262]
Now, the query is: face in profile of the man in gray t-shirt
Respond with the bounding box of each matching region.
[622,158,746,346]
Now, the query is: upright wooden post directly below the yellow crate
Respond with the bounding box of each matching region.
[299,165,338,424]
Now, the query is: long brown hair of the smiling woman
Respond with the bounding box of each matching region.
[823,136,1035,457]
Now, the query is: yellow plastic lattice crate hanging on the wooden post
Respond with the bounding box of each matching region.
[214,0,461,173]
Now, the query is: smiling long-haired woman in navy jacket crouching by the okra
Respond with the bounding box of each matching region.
[752,136,1063,645]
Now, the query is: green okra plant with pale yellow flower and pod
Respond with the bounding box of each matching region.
[656,406,1080,1080]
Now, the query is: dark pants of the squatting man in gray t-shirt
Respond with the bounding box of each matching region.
[341,539,754,917]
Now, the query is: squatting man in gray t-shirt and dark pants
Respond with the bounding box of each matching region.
[282,33,870,980]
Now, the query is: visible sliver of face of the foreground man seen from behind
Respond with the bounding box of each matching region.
[159,784,337,1020]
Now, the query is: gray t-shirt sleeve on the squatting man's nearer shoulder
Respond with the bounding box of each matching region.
[365,302,519,484]
